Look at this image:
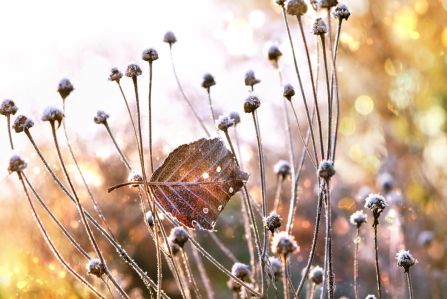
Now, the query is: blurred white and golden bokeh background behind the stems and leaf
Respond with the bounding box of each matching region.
[0,0,447,298]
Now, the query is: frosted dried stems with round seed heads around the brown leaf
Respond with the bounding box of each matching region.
[1,0,420,299]
